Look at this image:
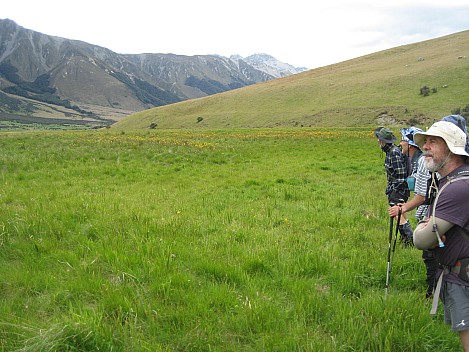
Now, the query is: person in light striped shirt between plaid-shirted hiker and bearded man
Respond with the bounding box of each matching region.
[388,127,438,298]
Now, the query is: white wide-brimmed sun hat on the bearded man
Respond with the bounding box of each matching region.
[414,121,469,156]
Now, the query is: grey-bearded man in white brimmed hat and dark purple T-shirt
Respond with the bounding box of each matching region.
[414,121,469,351]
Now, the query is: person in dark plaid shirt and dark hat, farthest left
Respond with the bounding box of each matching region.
[375,127,412,243]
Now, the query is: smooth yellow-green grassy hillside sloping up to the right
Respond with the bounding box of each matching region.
[113,31,469,129]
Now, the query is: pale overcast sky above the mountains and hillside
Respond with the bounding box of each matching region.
[0,0,469,68]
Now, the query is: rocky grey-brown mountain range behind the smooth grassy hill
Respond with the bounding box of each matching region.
[0,19,294,120]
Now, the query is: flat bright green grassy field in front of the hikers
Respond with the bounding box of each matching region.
[0,128,459,352]
